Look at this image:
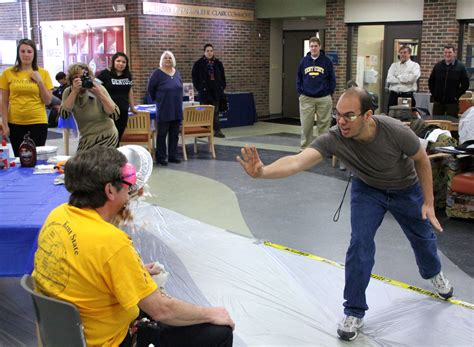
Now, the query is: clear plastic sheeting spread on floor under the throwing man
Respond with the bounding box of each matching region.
[128,202,474,346]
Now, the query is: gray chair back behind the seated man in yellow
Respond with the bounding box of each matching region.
[21,275,87,347]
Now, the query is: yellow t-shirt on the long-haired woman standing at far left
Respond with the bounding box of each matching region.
[0,67,53,125]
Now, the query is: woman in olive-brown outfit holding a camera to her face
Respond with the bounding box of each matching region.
[59,63,120,152]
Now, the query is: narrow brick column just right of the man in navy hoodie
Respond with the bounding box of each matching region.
[324,0,347,105]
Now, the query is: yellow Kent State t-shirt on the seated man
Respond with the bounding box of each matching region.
[33,204,157,346]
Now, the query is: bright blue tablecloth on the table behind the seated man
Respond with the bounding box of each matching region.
[0,167,69,276]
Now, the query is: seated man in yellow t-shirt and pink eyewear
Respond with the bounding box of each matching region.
[33,147,234,346]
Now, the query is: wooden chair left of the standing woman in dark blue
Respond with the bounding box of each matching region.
[120,111,155,157]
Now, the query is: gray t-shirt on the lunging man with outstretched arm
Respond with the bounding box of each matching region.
[311,116,420,189]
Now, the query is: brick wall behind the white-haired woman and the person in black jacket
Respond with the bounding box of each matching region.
[130,0,270,117]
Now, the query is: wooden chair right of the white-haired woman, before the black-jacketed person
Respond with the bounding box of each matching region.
[181,105,216,160]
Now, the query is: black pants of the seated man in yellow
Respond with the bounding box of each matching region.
[120,323,234,347]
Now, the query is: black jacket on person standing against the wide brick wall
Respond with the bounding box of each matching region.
[192,56,226,101]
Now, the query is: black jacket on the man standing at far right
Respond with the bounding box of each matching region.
[428,60,469,104]
